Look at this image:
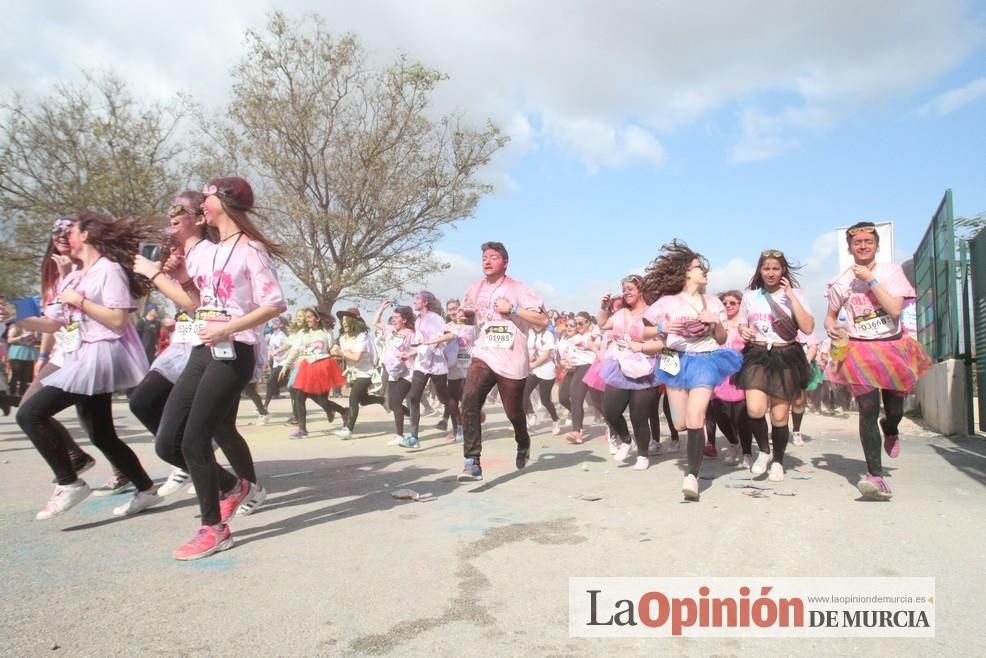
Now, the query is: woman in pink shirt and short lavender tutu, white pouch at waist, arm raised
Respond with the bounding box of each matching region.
[599,274,659,471]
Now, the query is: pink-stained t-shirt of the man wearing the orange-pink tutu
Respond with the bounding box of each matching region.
[828,263,916,340]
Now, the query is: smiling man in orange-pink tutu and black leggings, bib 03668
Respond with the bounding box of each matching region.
[825,222,931,500]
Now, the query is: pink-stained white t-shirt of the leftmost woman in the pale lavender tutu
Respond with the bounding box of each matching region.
[45,258,137,343]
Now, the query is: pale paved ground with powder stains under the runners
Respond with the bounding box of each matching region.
[0,392,986,656]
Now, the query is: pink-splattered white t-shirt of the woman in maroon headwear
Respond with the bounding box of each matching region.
[185,240,287,345]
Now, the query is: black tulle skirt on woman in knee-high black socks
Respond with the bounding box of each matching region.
[733,343,811,402]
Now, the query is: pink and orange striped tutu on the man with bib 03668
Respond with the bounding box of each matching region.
[825,334,931,395]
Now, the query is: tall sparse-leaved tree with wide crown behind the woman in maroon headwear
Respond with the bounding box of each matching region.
[204,13,507,311]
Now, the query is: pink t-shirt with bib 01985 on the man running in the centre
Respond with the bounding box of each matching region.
[463,276,544,379]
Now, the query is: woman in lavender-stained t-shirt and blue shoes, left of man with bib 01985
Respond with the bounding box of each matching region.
[398,290,458,448]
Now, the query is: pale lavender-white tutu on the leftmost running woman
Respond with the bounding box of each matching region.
[41,325,147,395]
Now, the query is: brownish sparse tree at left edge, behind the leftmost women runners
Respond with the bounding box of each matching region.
[0,73,187,292]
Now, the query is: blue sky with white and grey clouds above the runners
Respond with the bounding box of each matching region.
[0,0,986,322]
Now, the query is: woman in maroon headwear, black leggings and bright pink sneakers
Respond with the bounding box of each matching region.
[144,177,285,560]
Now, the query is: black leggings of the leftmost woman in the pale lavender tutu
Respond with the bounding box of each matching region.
[17,386,154,491]
